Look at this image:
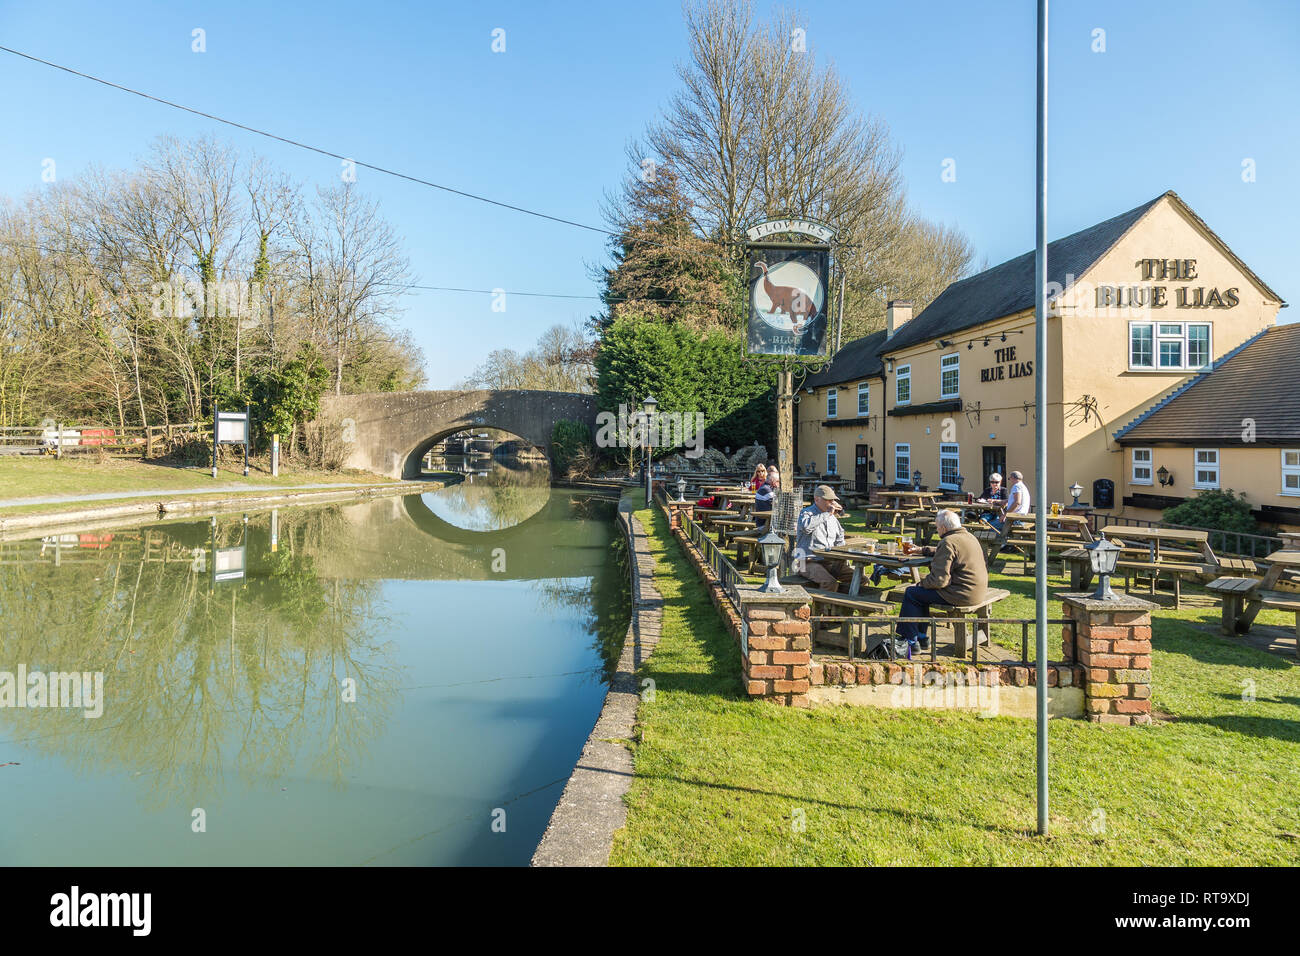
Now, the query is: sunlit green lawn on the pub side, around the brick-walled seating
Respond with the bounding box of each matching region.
[611,510,1300,865]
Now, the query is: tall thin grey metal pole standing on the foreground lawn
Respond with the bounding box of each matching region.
[1034,0,1048,836]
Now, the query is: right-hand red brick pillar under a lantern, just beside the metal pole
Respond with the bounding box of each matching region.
[1058,593,1157,724]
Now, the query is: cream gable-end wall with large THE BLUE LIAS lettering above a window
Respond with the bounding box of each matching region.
[1053,196,1281,511]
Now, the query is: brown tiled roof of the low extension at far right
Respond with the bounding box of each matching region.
[1115,323,1300,447]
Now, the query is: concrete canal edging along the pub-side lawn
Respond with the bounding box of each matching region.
[532,498,663,866]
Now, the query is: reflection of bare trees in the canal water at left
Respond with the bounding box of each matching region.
[0,509,399,805]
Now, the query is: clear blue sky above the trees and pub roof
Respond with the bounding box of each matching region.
[0,0,1300,388]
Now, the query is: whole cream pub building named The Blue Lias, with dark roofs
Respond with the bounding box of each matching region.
[796,191,1300,528]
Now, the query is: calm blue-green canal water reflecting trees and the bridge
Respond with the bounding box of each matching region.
[0,462,629,866]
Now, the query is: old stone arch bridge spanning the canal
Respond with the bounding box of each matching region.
[320,389,595,479]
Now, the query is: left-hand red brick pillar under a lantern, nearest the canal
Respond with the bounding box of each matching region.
[737,584,813,708]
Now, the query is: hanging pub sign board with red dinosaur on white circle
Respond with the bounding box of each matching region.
[746,245,831,358]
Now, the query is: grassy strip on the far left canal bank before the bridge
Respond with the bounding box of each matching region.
[0,455,387,514]
